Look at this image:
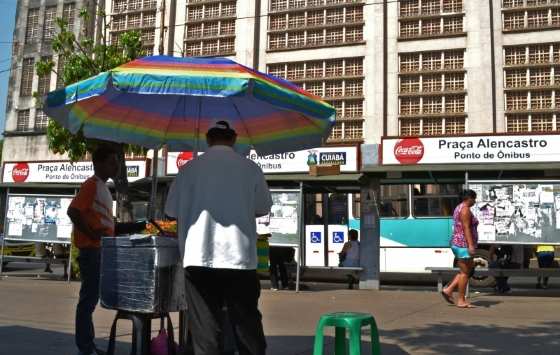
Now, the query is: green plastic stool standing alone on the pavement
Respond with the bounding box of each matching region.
[313,312,381,355]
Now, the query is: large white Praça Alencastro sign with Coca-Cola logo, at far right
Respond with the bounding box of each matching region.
[381,134,560,165]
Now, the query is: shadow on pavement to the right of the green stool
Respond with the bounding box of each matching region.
[381,322,560,355]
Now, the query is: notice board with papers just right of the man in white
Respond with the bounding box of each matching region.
[257,190,299,246]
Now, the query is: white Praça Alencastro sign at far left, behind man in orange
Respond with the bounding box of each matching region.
[2,160,147,184]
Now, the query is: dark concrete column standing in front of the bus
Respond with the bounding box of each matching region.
[360,176,381,290]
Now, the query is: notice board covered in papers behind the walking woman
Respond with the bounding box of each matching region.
[469,181,560,244]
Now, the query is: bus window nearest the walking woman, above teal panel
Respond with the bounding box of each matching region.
[412,184,462,217]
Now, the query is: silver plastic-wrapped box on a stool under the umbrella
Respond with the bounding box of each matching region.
[100,236,186,313]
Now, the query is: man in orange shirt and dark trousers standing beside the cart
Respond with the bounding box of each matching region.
[67,147,119,355]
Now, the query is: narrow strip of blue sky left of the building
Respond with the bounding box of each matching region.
[0,0,17,132]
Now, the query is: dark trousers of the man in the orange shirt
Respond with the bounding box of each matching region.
[76,249,101,354]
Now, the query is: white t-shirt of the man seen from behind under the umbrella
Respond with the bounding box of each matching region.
[165,146,272,270]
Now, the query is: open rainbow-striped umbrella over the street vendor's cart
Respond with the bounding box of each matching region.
[43,56,335,154]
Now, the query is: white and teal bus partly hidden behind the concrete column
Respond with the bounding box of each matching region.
[304,183,463,273]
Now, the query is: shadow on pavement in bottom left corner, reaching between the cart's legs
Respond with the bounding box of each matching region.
[0,326,124,355]
